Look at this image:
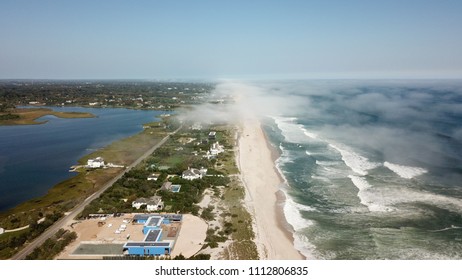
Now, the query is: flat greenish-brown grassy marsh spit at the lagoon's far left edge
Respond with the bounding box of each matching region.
[0,108,95,125]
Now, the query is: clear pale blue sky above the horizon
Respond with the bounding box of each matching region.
[0,0,462,79]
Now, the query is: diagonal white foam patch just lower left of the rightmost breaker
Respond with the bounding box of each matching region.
[348,175,394,212]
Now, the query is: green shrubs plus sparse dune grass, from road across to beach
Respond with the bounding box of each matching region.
[75,125,258,259]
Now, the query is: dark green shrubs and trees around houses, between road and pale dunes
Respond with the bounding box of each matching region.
[80,126,235,218]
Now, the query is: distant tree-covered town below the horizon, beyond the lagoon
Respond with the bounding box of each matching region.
[0,80,218,113]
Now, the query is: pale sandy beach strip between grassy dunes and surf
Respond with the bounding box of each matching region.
[237,119,305,260]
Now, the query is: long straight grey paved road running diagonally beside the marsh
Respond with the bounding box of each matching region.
[11,126,183,260]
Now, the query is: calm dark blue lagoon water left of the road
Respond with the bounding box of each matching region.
[0,107,165,211]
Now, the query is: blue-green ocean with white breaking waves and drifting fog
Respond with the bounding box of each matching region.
[264,81,462,260]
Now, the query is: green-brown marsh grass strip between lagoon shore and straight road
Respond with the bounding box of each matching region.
[0,118,173,259]
